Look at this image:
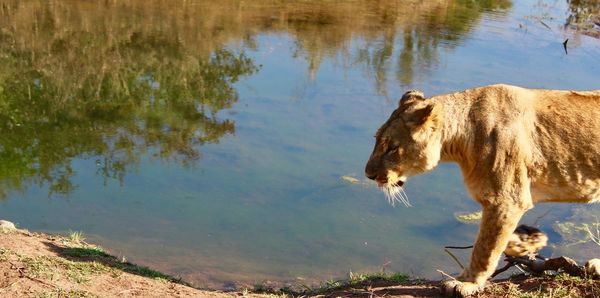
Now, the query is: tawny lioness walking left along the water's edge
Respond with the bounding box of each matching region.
[365,85,600,296]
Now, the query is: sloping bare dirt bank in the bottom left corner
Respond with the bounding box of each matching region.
[0,226,260,297]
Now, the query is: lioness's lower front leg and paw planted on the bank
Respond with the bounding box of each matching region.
[442,206,527,297]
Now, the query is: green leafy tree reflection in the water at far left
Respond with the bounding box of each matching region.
[0,2,257,198]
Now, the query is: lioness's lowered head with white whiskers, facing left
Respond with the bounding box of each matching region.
[365,91,443,205]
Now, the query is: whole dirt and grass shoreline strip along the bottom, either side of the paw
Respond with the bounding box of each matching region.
[0,221,600,298]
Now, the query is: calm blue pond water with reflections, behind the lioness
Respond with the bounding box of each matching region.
[0,0,600,288]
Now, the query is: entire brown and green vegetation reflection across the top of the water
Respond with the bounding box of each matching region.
[0,0,511,198]
